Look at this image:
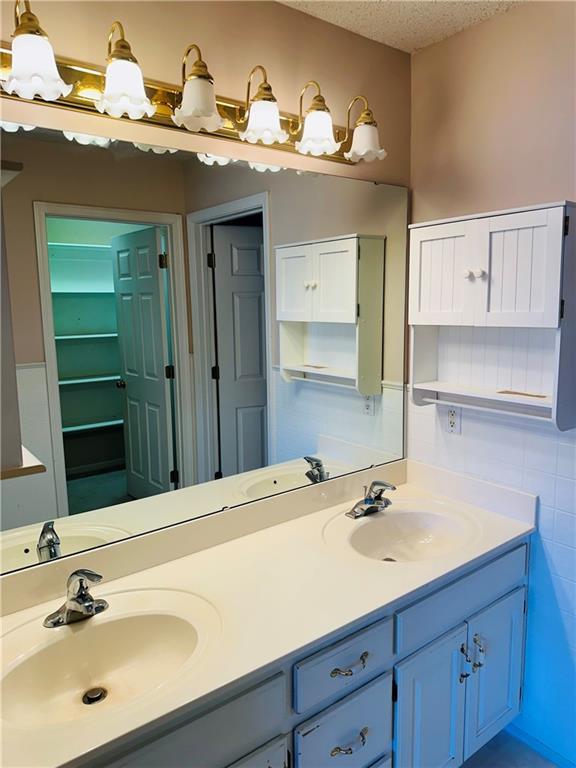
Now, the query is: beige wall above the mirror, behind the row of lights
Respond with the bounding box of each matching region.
[0,0,410,185]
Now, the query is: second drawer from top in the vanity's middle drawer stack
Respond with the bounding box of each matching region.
[294,672,392,768]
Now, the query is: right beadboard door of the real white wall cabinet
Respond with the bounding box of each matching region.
[474,207,564,328]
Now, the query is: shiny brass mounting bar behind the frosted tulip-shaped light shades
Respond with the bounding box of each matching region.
[0,42,353,165]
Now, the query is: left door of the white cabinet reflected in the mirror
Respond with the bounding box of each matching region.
[276,245,314,322]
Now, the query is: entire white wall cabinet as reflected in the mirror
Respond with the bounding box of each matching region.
[276,235,385,395]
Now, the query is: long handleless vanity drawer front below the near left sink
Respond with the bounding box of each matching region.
[107,674,288,768]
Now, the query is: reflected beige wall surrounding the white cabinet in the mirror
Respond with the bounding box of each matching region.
[186,162,408,382]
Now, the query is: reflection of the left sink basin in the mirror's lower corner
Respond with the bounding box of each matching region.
[0,518,131,572]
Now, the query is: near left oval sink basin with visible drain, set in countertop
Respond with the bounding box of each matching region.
[1,589,220,729]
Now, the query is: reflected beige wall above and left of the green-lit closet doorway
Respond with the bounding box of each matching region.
[2,135,185,364]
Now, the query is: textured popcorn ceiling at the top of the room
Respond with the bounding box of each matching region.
[282,0,521,53]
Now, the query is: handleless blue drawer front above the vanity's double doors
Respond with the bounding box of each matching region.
[396,545,527,656]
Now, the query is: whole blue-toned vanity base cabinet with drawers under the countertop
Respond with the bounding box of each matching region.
[97,544,527,768]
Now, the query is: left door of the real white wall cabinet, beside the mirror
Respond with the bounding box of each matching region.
[409,221,481,325]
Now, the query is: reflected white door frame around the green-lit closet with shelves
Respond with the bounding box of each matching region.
[33,202,195,517]
